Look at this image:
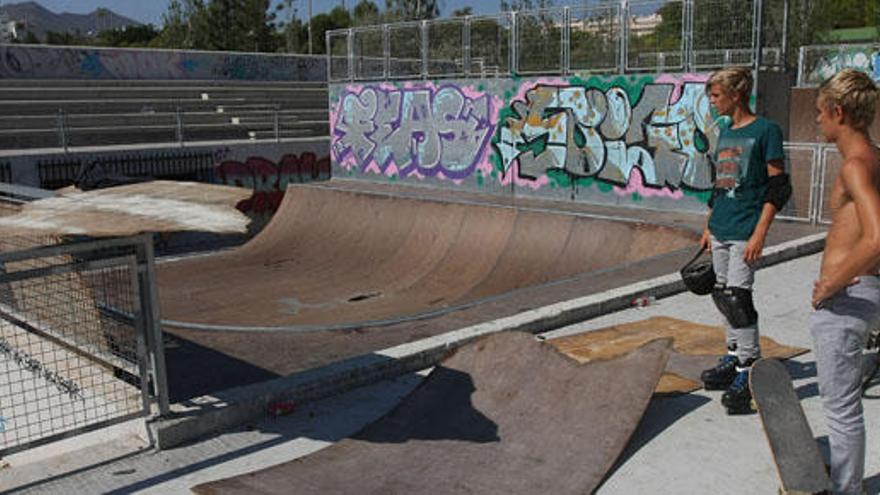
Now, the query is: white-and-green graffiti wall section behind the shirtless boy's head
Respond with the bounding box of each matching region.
[797,43,880,87]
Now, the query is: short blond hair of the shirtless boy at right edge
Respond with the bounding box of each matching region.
[819,69,880,129]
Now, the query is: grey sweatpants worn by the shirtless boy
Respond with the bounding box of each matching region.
[810,276,880,494]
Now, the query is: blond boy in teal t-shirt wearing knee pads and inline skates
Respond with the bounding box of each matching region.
[700,67,791,414]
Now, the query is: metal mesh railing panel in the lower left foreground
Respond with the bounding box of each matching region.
[0,235,169,456]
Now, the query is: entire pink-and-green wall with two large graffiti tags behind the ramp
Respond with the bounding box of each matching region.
[330,74,719,209]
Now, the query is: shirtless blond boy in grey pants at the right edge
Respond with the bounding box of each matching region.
[810,69,880,494]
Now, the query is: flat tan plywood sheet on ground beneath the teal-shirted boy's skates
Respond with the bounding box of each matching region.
[547,316,808,394]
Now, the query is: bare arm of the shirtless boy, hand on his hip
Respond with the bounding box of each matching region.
[813,160,880,308]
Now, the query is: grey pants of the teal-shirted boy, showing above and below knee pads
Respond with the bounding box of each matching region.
[712,236,761,363]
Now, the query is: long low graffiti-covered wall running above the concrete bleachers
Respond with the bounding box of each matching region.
[0,44,327,81]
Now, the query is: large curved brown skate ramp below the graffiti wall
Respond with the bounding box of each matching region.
[158,182,697,330]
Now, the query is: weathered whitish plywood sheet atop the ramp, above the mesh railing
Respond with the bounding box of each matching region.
[0,181,252,237]
